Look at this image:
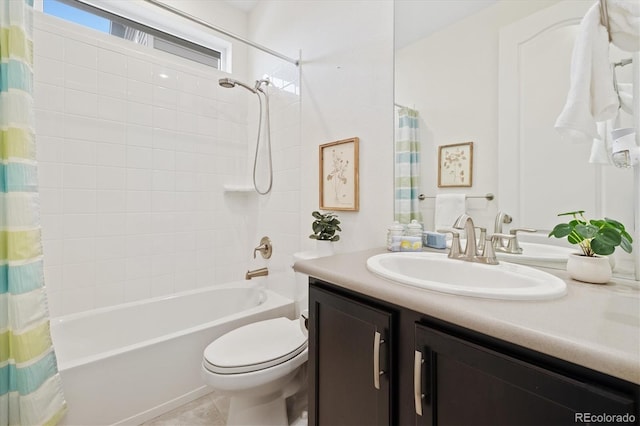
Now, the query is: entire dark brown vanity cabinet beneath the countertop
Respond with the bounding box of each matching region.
[309,278,640,426]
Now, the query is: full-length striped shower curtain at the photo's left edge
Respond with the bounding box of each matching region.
[0,0,66,426]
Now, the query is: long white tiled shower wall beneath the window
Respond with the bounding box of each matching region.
[34,13,298,316]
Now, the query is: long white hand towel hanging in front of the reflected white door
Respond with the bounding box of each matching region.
[555,3,618,142]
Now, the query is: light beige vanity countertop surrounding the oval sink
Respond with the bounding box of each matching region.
[294,248,640,384]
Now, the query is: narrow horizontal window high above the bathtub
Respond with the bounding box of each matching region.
[42,0,231,72]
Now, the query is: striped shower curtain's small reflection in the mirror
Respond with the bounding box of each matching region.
[394,107,422,223]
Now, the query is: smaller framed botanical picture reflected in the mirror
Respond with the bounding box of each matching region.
[438,142,473,188]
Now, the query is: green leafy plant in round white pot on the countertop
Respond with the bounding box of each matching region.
[549,210,633,284]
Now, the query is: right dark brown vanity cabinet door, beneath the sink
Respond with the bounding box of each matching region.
[413,324,638,426]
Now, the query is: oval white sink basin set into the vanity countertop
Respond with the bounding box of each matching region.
[367,252,567,300]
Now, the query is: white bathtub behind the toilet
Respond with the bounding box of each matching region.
[51,281,295,426]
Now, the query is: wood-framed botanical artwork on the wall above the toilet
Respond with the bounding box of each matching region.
[319,138,360,211]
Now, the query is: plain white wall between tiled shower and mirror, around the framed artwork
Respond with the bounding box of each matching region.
[249,0,393,251]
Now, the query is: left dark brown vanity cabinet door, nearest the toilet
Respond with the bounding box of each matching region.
[309,286,392,426]
